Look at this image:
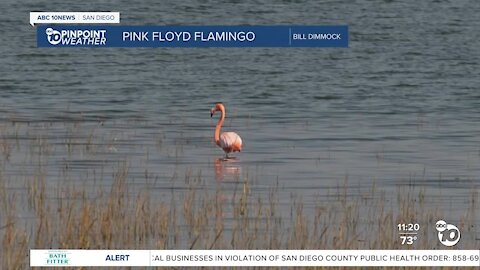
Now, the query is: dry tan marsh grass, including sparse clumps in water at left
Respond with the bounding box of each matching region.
[0,123,479,269]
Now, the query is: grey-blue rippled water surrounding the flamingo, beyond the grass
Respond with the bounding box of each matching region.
[0,0,480,243]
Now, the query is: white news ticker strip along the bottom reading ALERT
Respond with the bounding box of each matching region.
[30,249,480,267]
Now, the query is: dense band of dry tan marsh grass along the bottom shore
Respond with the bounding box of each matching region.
[0,170,478,269]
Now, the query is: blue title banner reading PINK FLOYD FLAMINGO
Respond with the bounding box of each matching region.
[37,25,348,47]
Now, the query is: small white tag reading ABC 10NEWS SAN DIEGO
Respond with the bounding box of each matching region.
[30,12,120,26]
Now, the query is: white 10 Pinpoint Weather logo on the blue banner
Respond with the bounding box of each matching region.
[45,27,107,46]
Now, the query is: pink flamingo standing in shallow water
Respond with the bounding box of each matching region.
[210,103,242,159]
